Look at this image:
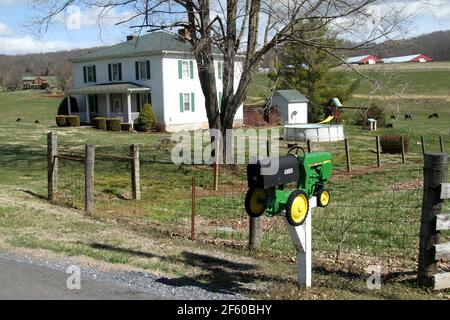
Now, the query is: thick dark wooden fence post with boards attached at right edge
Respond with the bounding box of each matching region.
[418,153,448,286]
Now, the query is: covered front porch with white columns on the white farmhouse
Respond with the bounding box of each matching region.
[65,83,151,126]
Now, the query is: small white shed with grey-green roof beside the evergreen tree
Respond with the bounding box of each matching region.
[272,90,309,124]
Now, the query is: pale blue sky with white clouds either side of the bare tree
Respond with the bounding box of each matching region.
[0,0,450,54]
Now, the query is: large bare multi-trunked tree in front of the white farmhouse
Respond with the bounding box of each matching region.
[34,0,401,154]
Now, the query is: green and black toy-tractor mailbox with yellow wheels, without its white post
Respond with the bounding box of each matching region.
[245,146,332,226]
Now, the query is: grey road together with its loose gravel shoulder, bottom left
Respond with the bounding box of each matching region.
[0,252,245,300]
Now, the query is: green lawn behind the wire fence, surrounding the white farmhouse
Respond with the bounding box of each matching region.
[0,70,450,298]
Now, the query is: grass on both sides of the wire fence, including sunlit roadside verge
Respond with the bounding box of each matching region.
[0,64,450,298]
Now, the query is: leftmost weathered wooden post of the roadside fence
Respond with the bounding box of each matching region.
[47,131,58,202]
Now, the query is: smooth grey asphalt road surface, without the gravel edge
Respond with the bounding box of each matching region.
[0,257,166,300]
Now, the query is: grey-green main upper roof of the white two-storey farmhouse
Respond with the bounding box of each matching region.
[70,31,223,62]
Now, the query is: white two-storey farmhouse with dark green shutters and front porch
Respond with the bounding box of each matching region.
[66,31,243,131]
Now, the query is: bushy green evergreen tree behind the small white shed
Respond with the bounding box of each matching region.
[269,21,359,121]
